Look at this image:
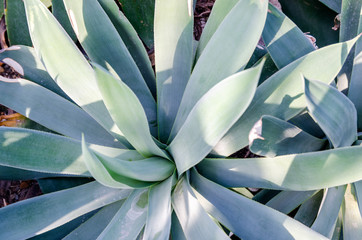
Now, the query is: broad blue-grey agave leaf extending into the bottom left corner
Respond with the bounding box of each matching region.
[0,182,130,240]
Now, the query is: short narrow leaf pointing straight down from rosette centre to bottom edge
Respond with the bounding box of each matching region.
[143,174,176,240]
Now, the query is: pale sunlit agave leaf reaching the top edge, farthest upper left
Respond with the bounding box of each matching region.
[24,0,130,147]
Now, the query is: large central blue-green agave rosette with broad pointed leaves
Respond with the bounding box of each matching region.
[0,0,362,239]
